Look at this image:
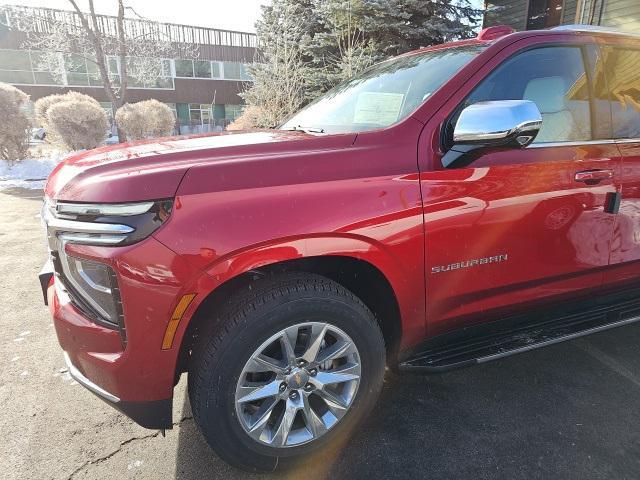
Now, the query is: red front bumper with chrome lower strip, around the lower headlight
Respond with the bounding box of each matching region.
[40,237,197,429]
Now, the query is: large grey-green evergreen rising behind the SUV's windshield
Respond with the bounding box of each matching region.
[236,0,480,127]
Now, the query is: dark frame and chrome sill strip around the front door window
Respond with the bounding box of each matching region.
[439,41,613,152]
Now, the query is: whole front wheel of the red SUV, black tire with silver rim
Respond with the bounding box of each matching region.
[188,273,385,471]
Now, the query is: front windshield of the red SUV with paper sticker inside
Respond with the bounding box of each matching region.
[281,45,485,133]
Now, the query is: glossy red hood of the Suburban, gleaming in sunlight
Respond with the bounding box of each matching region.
[45,130,356,203]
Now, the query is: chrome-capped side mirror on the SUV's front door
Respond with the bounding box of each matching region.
[442,100,542,168]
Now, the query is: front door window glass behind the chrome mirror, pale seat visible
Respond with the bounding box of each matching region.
[458,47,592,143]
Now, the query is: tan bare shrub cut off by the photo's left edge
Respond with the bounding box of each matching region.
[0,83,30,161]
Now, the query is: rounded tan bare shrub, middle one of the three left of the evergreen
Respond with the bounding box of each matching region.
[46,99,109,150]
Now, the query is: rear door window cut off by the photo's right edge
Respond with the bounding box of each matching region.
[605,48,640,138]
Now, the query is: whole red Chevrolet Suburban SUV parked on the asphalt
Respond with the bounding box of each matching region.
[41,27,640,470]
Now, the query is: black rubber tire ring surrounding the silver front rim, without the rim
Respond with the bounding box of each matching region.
[190,286,385,470]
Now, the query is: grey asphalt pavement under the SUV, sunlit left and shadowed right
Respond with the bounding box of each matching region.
[0,190,640,480]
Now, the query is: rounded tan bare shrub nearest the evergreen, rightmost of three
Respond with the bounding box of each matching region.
[116,100,176,140]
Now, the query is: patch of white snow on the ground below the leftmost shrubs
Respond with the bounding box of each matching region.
[0,152,68,190]
